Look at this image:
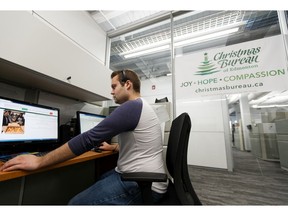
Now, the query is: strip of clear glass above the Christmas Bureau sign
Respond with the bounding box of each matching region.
[174,11,280,55]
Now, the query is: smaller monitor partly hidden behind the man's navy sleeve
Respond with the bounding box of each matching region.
[76,111,106,134]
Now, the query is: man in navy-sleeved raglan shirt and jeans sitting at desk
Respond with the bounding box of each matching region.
[0,70,168,205]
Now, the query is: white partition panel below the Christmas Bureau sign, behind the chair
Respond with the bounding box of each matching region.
[176,96,232,170]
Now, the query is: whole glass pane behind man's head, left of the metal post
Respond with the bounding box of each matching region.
[110,12,172,103]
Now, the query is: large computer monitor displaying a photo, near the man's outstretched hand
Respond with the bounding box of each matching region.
[0,97,59,153]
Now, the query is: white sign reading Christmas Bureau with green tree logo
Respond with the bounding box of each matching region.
[175,35,288,99]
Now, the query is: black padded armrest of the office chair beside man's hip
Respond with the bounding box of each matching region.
[121,172,167,182]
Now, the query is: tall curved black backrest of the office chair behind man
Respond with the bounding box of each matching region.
[166,113,201,205]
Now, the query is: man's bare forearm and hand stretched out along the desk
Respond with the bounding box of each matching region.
[0,143,76,171]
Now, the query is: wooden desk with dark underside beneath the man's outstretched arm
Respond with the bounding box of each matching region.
[0,151,118,205]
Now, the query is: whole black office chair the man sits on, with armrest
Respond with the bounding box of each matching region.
[121,113,202,205]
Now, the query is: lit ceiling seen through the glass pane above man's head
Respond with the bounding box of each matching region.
[110,12,171,79]
